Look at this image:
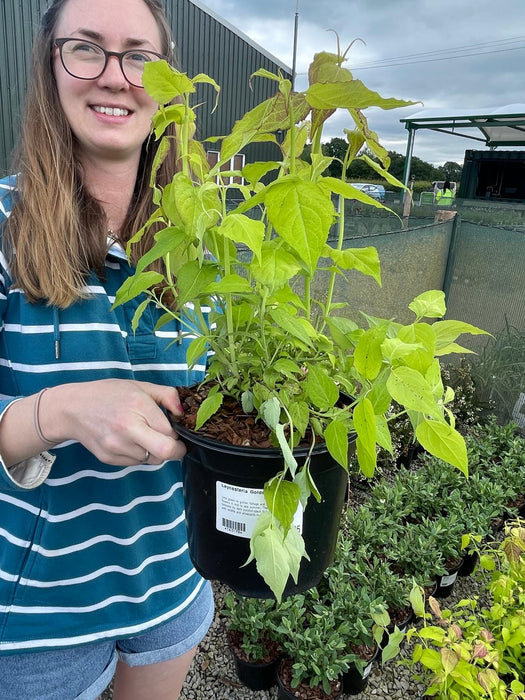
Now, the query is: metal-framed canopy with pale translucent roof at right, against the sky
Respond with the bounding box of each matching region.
[400,104,525,185]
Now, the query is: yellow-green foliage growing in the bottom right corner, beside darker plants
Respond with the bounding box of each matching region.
[400,521,525,700]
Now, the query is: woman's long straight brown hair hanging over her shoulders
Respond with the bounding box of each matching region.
[5,0,177,308]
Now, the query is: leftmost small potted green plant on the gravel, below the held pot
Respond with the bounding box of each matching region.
[222,591,282,690]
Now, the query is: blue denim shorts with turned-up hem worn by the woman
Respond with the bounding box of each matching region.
[0,582,214,700]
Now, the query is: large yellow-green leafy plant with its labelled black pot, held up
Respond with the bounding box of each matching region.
[115,38,488,598]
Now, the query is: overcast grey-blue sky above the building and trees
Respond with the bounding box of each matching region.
[195,0,525,164]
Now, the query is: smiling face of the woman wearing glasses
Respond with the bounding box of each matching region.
[54,0,162,167]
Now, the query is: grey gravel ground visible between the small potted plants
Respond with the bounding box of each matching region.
[101,577,479,700]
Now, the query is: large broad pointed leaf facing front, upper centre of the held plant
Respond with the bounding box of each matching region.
[264,175,334,273]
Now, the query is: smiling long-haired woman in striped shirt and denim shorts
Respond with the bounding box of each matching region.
[0,0,213,700]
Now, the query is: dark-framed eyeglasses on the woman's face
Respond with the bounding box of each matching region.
[55,38,166,88]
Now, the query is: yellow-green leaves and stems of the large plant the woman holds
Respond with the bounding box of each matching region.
[116,38,488,599]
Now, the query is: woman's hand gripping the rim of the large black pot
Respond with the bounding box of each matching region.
[40,379,186,465]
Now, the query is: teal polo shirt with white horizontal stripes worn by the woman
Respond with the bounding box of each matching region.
[0,178,209,654]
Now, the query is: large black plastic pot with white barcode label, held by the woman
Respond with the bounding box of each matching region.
[177,418,355,598]
